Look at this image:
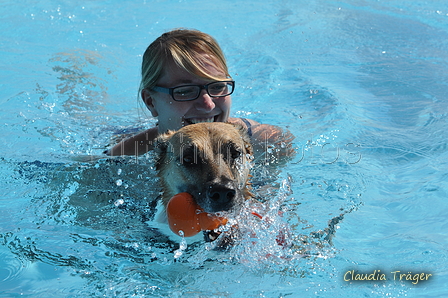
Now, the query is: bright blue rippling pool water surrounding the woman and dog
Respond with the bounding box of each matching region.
[0,0,448,297]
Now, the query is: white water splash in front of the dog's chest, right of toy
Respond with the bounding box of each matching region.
[170,177,314,270]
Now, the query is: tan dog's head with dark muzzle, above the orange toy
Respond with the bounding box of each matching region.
[155,122,252,212]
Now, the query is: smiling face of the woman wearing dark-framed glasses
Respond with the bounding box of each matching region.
[142,62,232,133]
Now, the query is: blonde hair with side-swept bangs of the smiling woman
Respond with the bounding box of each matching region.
[139,29,230,93]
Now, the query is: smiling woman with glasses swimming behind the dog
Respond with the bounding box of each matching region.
[107,29,293,161]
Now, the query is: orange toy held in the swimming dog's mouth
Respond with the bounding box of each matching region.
[166,192,227,237]
